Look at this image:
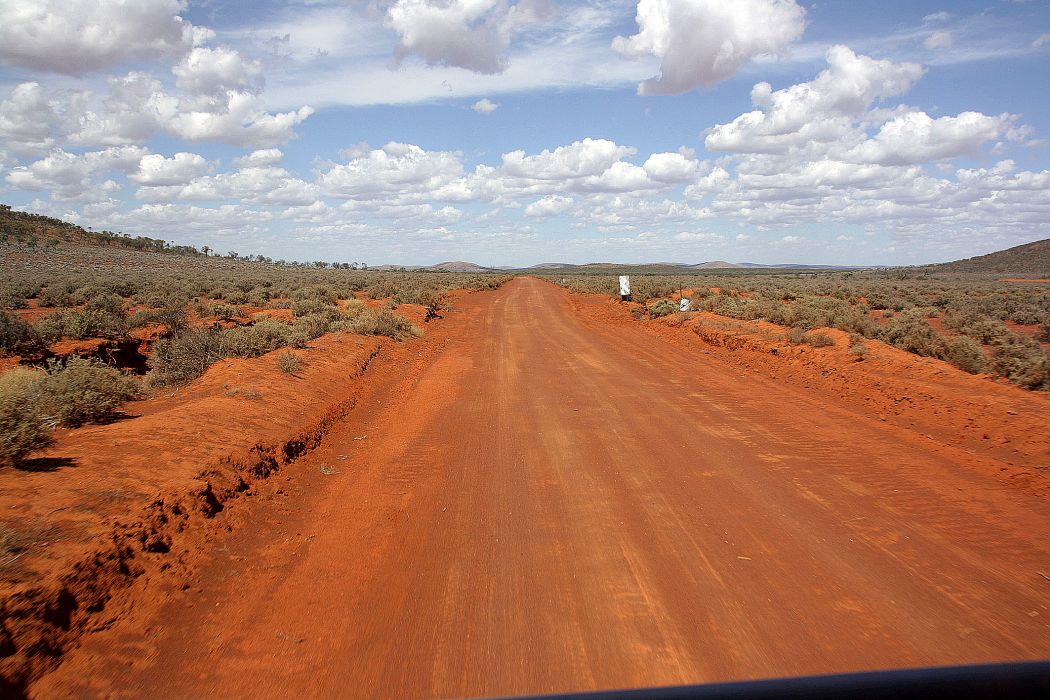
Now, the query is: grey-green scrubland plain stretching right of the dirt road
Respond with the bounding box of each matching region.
[549,271,1050,389]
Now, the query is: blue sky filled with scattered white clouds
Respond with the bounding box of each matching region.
[0,0,1050,266]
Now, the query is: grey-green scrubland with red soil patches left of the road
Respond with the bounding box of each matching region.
[0,212,507,463]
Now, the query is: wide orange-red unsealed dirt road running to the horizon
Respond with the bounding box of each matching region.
[32,279,1050,698]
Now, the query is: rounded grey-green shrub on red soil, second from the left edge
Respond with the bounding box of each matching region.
[40,357,140,427]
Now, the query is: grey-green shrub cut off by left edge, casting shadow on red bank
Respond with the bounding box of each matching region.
[0,367,51,466]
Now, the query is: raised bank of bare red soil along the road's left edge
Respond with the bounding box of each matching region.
[0,334,389,687]
